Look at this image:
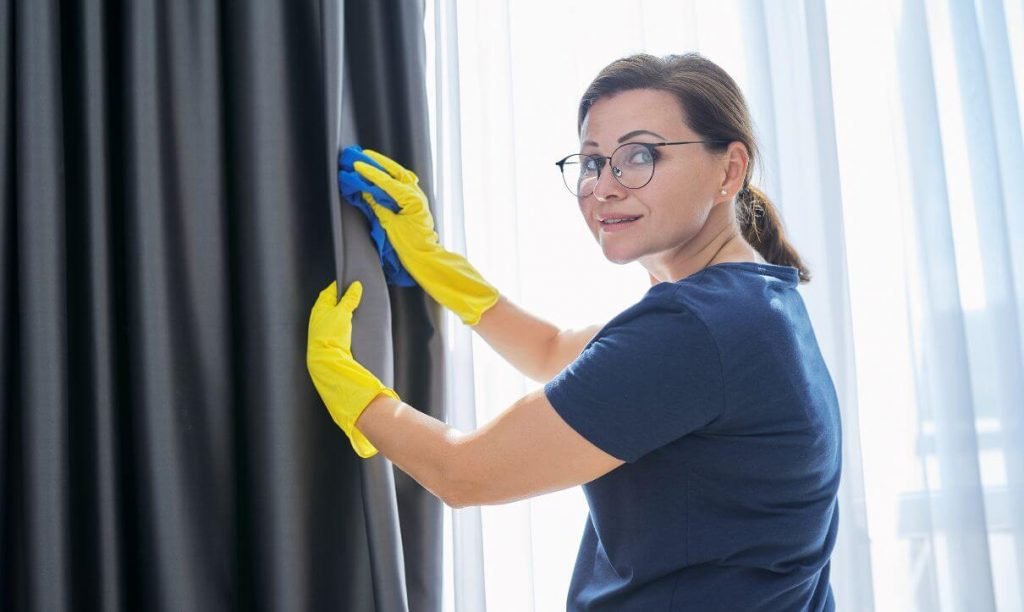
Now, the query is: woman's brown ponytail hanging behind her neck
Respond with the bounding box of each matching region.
[736,185,811,282]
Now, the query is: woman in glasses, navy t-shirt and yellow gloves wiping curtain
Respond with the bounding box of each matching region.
[309,54,841,610]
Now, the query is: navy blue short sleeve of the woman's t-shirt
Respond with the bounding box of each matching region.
[544,298,724,463]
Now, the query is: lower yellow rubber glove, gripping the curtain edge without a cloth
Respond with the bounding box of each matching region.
[306,280,401,458]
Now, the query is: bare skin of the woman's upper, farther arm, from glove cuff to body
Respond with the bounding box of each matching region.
[473,296,601,383]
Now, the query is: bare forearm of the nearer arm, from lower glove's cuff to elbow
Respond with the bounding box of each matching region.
[355,395,463,508]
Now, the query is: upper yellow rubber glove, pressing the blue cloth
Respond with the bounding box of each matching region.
[352,149,500,325]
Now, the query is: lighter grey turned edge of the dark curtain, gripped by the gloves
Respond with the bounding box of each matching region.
[321,0,409,611]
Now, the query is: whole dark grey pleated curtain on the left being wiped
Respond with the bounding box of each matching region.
[0,0,442,611]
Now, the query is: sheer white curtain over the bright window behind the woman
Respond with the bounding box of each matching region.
[427,0,1024,612]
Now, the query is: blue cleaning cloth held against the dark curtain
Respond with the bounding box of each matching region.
[338,144,416,287]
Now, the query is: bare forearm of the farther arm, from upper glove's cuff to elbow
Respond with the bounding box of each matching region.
[473,296,560,383]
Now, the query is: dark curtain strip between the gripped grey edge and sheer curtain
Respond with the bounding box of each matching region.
[341,0,445,611]
